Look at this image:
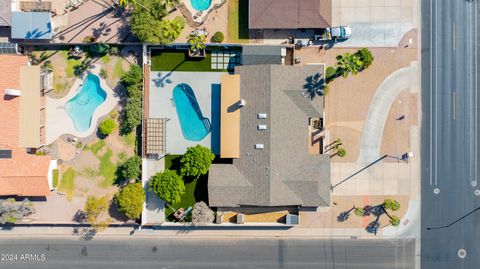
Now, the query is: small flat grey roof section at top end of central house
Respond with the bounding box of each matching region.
[242,45,283,65]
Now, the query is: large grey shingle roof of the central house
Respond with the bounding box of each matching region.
[208,65,330,207]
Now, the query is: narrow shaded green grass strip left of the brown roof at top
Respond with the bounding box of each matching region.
[228,0,248,43]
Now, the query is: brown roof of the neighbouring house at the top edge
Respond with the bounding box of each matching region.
[248,0,332,29]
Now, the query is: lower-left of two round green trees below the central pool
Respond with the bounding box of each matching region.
[150,169,185,204]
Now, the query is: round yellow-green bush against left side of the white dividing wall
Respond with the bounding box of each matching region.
[115,182,145,219]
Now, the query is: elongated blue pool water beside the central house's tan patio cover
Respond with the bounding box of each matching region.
[172,83,210,141]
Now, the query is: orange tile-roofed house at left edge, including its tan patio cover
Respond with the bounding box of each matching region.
[0,54,56,197]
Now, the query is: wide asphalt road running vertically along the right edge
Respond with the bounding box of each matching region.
[421,0,480,269]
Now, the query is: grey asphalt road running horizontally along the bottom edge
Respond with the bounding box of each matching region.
[0,237,415,269]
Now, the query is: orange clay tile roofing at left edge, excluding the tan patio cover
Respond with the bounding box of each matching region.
[0,54,51,196]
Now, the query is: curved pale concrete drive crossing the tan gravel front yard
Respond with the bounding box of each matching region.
[358,62,419,163]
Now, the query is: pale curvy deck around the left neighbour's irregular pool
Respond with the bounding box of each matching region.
[45,64,120,145]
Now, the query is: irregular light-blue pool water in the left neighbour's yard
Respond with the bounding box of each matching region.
[65,74,107,132]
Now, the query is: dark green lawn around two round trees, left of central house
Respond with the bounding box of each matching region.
[165,155,208,221]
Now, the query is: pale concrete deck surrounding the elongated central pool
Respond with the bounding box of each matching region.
[149,71,226,154]
